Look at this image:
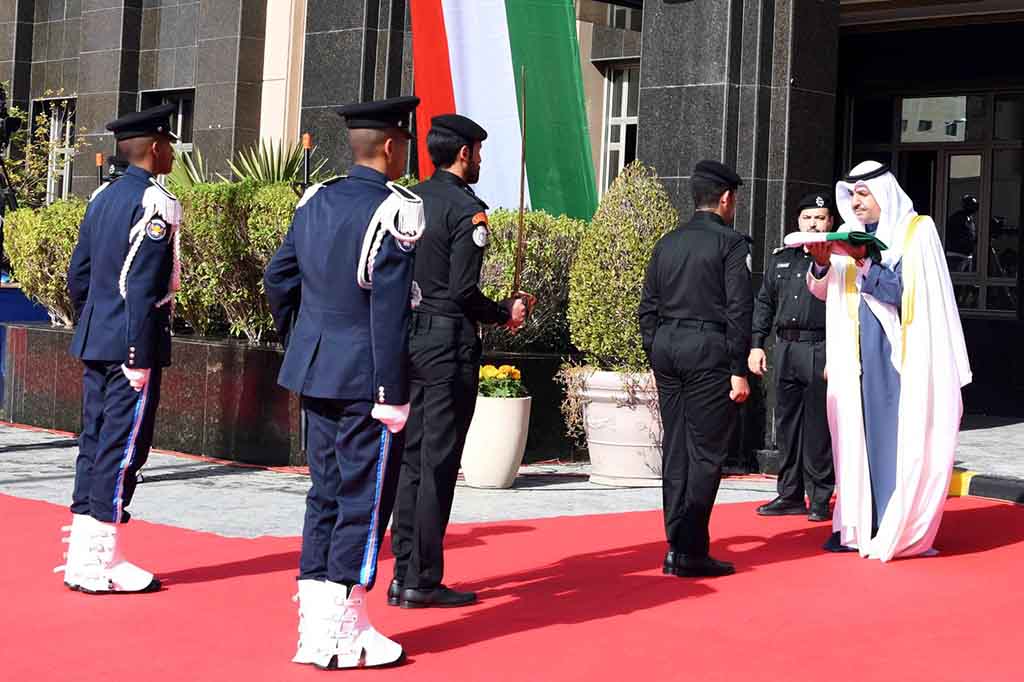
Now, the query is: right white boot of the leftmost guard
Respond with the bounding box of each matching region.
[77,516,160,594]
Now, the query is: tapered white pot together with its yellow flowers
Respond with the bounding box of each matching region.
[462,365,531,487]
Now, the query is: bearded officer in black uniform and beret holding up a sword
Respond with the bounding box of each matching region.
[388,114,526,608]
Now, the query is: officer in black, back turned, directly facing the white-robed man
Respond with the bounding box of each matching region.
[639,161,754,577]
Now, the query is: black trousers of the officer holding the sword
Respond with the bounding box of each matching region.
[391,314,481,590]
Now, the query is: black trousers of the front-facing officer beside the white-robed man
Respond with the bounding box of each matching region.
[774,338,836,507]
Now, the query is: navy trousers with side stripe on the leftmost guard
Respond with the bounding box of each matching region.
[71,360,162,523]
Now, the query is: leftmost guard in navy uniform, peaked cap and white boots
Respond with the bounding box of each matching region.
[57,105,181,593]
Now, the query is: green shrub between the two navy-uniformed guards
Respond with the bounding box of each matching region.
[178,182,298,343]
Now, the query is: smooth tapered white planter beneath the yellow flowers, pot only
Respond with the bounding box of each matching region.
[462,395,531,487]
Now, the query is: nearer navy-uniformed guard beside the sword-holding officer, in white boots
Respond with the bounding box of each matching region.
[264,97,424,670]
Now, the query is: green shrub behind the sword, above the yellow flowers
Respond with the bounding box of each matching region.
[480,210,587,353]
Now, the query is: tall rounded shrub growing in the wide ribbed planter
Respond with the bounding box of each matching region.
[568,162,679,372]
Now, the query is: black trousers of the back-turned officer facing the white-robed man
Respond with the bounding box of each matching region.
[650,322,738,558]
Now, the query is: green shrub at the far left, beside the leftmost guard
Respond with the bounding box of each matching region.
[4,199,85,327]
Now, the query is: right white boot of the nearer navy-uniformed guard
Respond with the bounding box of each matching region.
[327,583,406,669]
